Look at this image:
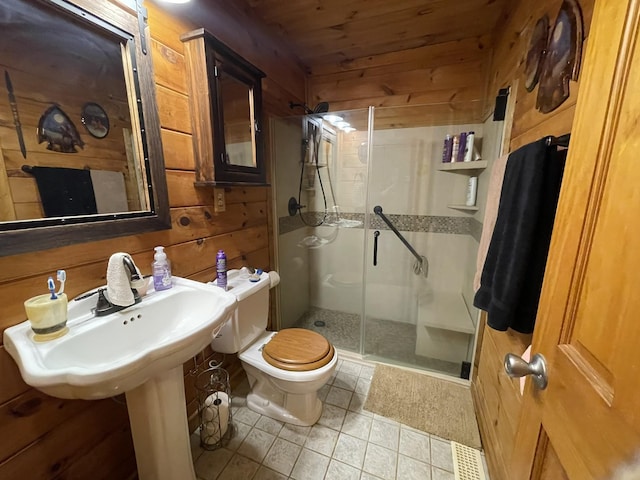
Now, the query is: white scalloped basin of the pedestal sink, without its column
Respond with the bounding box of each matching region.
[4,277,236,399]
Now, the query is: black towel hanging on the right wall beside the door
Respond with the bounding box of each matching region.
[473,138,566,333]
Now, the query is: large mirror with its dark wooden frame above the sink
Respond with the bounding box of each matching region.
[0,0,170,255]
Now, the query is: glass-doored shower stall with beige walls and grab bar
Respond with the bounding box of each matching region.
[271,102,502,378]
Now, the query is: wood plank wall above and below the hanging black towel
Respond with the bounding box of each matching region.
[472,0,595,480]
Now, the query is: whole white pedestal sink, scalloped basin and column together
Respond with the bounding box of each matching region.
[4,277,236,480]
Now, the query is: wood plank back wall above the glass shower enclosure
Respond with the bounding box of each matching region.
[307,35,491,128]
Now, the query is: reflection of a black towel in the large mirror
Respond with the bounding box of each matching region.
[22,166,98,217]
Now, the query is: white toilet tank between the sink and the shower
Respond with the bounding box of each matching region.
[211,269,272,353]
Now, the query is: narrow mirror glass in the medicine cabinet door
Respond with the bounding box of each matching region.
[220,73,256,167]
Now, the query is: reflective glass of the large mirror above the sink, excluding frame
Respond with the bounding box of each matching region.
[0,0,150,221]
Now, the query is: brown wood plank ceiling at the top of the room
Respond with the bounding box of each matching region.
[236,0,508,74]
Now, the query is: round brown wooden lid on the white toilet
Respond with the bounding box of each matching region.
[262,328,334,372]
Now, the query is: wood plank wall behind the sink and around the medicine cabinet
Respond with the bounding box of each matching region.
[0,2,304,480]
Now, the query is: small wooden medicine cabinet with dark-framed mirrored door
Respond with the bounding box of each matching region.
[181,28,266,186]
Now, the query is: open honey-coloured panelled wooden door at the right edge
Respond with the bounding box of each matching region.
[511,0,640,480]
